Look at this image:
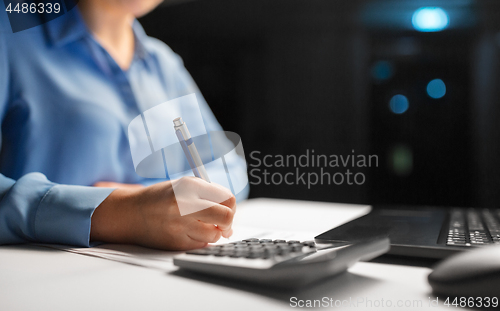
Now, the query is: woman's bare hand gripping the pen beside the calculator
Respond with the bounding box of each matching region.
[90,177,236,250]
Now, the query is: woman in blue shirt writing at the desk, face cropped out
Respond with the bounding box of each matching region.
[0,0,248,250]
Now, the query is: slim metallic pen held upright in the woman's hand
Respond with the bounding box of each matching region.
[174,117,210,182]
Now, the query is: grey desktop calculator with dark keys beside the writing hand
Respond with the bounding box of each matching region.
[174,237,390,287]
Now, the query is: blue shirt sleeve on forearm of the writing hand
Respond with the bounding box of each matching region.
[0,30,114,247]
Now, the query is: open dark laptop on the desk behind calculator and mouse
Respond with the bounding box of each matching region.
[315,205,500,258]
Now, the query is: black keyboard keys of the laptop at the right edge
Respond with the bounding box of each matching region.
[446,209,500,246]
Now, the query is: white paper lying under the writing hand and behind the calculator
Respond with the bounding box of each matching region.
[39,199,370,270]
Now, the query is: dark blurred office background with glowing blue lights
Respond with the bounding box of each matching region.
[141,0,500,210]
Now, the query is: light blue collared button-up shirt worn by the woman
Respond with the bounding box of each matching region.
[0,4,248,246]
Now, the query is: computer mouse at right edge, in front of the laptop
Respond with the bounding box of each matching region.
[428,245,500,297]
